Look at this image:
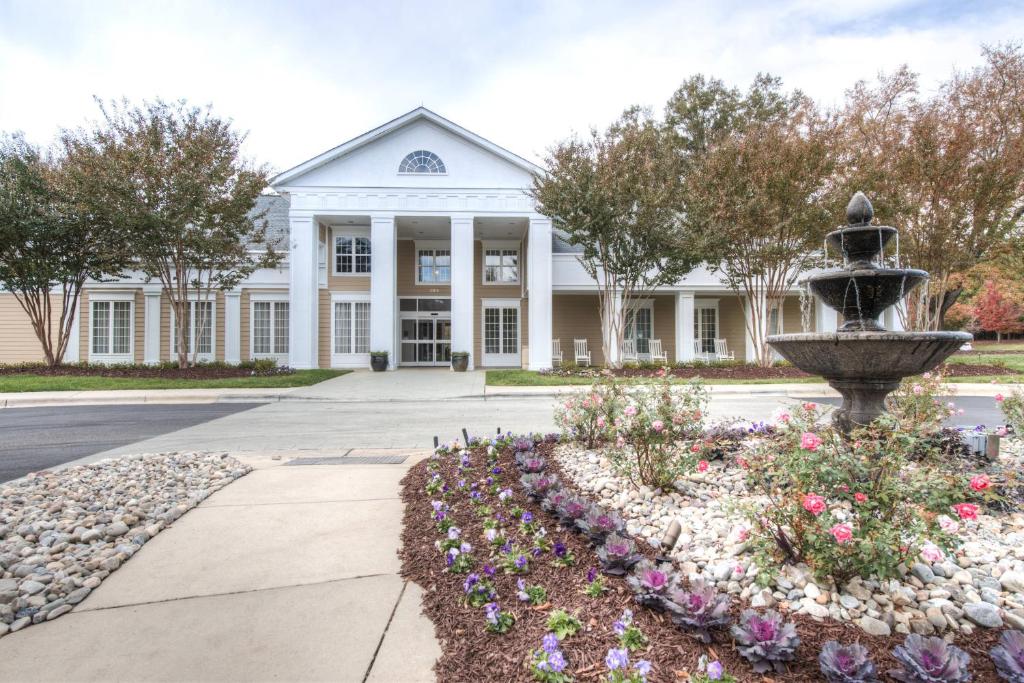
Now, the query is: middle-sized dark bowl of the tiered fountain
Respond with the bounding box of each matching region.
[808,268,928,332]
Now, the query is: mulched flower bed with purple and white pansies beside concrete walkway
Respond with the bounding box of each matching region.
[401,439,999,681]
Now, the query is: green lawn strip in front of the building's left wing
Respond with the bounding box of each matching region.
[0,370,351,393]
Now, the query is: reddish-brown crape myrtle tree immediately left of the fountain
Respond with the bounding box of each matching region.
[666,75,835,366]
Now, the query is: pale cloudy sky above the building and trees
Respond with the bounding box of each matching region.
[0,0,1024,171]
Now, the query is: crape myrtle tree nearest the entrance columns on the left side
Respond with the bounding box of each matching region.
[63,99,281,368]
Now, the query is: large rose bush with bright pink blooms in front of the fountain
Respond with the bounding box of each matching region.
[744,403,970,581]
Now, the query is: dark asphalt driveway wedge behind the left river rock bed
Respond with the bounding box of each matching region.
[0,403,259,481]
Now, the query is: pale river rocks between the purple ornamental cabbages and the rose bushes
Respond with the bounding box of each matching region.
[556,439,1024,636]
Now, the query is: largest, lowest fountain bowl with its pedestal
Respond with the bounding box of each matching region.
[767,332,973,433]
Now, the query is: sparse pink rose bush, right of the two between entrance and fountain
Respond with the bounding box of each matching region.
[610,378,708,487]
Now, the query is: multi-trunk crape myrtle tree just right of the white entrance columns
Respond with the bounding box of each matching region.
[531,108,705,367]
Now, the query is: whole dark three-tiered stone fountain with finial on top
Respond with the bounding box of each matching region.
[767,193,972,433]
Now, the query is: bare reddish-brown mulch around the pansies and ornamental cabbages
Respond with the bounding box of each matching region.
[399,445,999,683]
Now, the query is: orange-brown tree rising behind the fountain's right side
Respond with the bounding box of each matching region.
[838,45,1024,330]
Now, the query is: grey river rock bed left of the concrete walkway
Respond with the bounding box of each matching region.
[0,453,252,637]
